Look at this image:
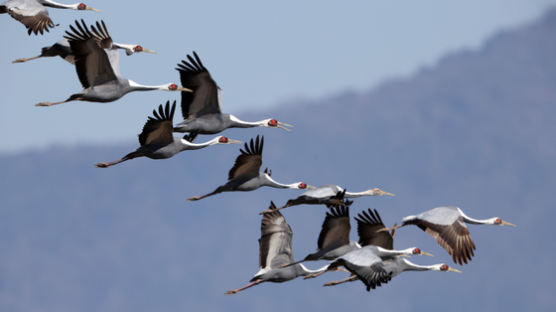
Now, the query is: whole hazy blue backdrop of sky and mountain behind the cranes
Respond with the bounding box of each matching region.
[0,1,556,311]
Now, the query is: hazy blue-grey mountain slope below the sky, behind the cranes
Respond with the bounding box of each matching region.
[0,10,556,311]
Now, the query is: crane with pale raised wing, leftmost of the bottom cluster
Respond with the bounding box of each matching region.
[226,202,327,295]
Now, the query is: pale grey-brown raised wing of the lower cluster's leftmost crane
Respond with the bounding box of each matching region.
[259,202,294,269]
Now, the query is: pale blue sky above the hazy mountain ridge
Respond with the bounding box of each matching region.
[0,0,556,152]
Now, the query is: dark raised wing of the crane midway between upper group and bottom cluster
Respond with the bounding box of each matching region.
[228,135,264,180]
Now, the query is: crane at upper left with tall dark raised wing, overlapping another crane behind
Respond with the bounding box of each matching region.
[36,20,191,106]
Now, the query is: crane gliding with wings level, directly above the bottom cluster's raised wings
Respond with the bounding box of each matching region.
[268,184,394,210]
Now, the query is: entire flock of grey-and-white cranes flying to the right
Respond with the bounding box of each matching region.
[0,0,515,294]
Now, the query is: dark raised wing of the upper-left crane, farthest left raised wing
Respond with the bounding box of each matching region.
[64,20,118,88]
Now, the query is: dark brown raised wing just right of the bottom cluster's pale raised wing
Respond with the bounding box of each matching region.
[318,206,351,250]
